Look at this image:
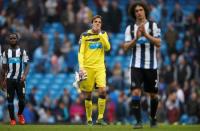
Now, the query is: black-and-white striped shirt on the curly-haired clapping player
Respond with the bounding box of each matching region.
[125,21,160,69]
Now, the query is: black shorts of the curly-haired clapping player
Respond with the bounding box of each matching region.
[131,67,159,93]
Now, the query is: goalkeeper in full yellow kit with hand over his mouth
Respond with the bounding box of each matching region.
[78,15,110,125]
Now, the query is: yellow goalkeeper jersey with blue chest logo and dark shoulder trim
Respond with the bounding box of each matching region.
[78,29,110,68]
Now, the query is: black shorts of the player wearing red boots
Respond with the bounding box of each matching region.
[7,79,25,102]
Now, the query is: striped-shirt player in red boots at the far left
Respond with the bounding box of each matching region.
[2,33,29,125]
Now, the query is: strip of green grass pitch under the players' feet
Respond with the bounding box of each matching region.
[0,124,200,131]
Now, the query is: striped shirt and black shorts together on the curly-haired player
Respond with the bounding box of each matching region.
[125,20,160,93]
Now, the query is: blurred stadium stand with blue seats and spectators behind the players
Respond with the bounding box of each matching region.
[0,0,200,124]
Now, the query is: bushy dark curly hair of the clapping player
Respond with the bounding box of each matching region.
[128,1,149,20]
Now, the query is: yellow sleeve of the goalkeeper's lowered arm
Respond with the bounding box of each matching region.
[78,36,85,70]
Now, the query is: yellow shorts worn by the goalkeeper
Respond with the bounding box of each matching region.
[80,68,106,92]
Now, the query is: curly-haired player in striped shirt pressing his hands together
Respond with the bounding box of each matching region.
[123,2,161,128]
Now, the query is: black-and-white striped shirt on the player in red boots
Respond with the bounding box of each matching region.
[3,47,29,80]
